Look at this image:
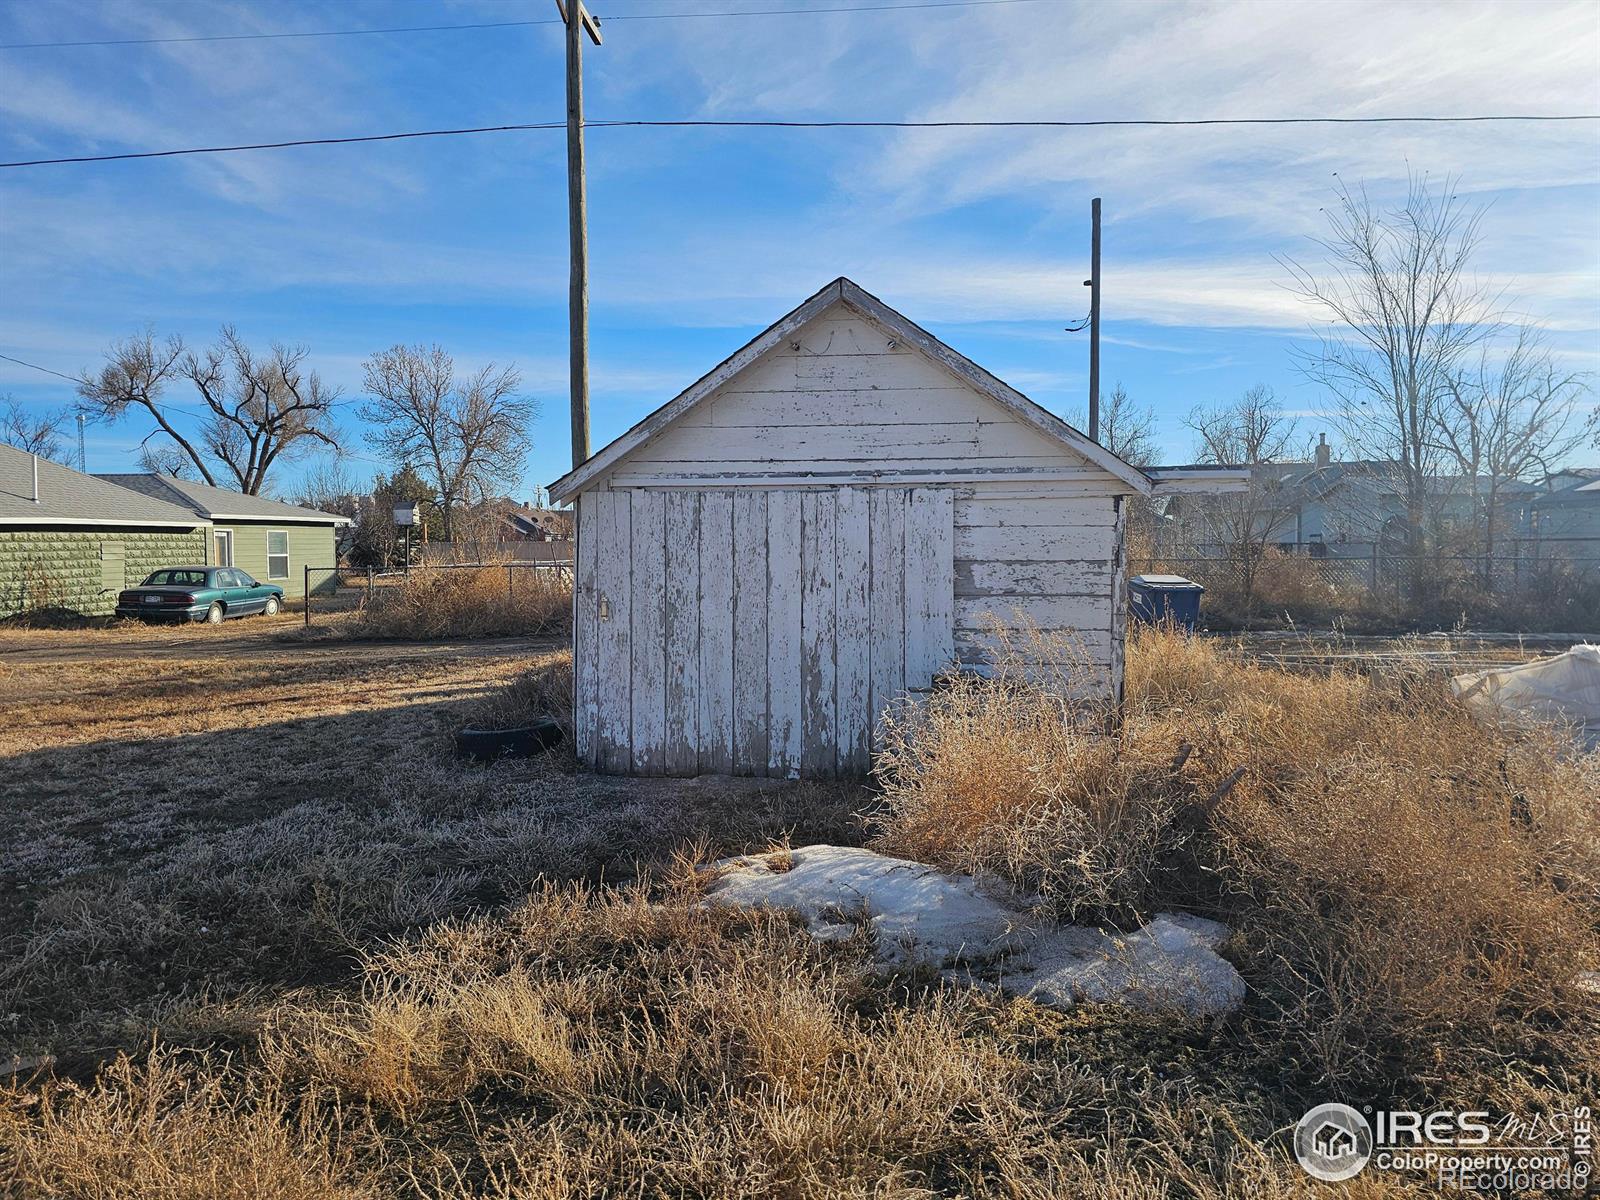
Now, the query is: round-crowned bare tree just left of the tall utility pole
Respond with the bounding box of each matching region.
[360,346,538,541]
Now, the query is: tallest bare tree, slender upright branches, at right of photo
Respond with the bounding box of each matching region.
[1283,174,1498,554]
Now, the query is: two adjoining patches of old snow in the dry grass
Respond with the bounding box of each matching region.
[706,846,1245,1018]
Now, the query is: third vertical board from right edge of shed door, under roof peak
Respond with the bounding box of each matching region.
[834,488,874,774]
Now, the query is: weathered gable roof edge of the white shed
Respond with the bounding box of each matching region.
[550,278,1154,504]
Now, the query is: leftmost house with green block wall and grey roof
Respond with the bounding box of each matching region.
[0,445,210,618]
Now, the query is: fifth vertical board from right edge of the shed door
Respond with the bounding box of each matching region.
[766,491,803,778]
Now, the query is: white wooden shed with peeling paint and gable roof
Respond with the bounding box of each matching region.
[550,278,1235,778]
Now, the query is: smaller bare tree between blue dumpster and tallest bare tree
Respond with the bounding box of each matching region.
[1184,384,1298,614]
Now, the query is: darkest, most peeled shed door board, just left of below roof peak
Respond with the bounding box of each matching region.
[800,491,840,779]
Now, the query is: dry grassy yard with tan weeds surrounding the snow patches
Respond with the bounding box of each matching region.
[0,624,1600,1200]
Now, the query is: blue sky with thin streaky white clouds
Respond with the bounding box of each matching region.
[0,0,1600,494]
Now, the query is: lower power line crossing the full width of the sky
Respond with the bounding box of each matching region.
[0,112,1600,168]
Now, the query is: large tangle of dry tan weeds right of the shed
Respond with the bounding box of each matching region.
[878,630,1600,1083]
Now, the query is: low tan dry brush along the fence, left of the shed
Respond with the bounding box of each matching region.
[349,565,573,638]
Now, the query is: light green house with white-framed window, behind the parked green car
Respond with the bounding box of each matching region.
[94,474,350,597]
